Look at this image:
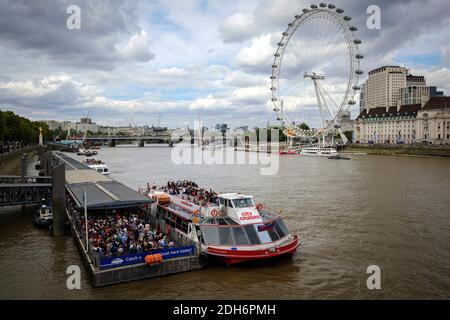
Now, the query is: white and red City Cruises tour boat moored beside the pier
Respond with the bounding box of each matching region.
[140,185,301,265]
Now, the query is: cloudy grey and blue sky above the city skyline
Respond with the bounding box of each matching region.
[0,0,450,127]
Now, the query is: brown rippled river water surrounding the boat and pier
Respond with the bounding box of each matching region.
[0,146,450,299]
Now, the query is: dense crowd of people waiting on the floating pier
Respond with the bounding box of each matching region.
[71,200,174,256]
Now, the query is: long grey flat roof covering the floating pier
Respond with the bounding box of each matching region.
[54,152,154,210]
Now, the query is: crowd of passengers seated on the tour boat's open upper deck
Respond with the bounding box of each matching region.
[163,180,219,205]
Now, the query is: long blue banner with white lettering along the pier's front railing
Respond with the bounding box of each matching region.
[100,245,195,269]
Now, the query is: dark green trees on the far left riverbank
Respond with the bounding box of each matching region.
[0,110,52,144]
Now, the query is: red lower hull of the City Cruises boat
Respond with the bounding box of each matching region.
[207,236,300,264]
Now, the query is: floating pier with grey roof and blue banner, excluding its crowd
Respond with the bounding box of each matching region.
[50,152,204,287]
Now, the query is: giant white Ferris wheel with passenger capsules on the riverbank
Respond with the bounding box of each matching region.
[270,3,363,141]
